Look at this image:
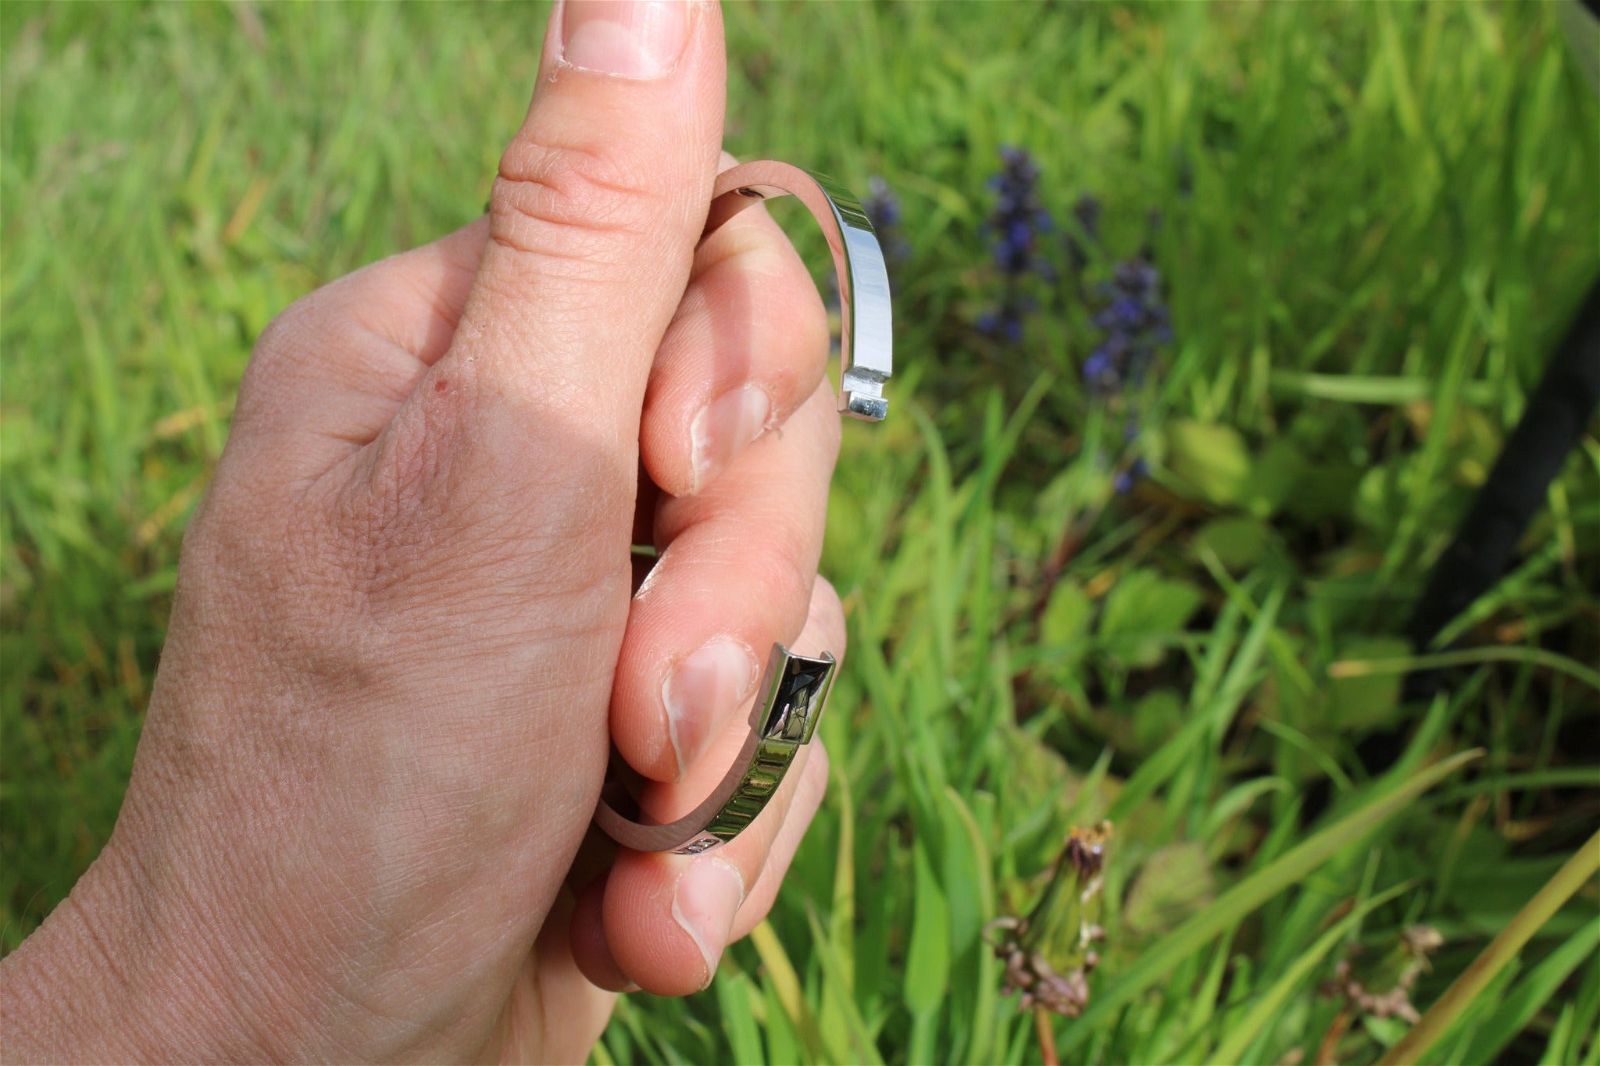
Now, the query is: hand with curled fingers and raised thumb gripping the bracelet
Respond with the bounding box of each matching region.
[3,0,843,1061]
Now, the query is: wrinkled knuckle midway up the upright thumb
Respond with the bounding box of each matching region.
[490,138,653,262]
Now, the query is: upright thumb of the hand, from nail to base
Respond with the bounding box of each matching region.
[368,0,725,521]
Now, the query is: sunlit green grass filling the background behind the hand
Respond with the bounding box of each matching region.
[0,3,1600,1063]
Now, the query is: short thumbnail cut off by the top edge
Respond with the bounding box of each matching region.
[562,0,690,78]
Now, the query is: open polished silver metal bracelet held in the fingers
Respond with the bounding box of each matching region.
[595,160,893,855]
